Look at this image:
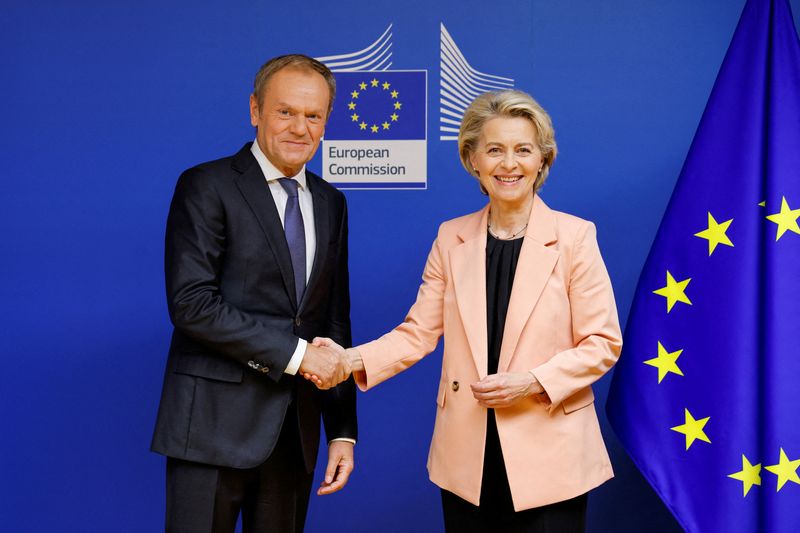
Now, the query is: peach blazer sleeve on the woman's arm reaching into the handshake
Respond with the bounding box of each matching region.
[353,231,447,391]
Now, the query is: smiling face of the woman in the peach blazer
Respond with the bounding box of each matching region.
[470,117,543,206]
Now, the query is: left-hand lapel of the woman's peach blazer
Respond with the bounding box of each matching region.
[450,206,489,378]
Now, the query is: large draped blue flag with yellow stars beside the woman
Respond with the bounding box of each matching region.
[608,0,800,533]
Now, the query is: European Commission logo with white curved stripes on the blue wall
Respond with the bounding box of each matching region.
[317,24,514,189]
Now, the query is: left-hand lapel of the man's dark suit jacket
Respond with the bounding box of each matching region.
[233,143,297,309]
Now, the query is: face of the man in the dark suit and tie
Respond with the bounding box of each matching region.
[250,67,330,177]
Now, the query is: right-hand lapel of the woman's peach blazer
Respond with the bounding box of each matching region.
[497,196,558,372]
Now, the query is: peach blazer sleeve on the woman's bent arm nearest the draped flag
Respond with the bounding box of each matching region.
[531,222,622,411]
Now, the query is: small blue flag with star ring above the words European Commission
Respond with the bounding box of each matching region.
[325,70,427,141]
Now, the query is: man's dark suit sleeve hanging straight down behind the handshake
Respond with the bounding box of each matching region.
[318,197,358,442]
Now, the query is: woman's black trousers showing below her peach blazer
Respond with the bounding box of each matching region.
[442,409,588,533]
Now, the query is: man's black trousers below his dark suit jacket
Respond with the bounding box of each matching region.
[166,408,314,533]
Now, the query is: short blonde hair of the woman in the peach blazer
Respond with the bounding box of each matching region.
[458,89,558,194]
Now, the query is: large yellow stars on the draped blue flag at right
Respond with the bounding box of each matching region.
[643,196,800,497]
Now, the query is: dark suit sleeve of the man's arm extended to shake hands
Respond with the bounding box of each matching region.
[164,168,298,381]
